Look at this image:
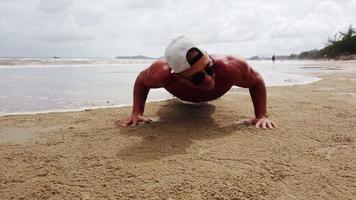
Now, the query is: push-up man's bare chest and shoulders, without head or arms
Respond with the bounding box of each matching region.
[144,56,247,102]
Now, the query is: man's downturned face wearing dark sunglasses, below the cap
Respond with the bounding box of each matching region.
[179,53,215,90]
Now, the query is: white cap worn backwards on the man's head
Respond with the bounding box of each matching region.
[164,36,204,73]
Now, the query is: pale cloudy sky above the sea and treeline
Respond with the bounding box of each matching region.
[0,0,356,58]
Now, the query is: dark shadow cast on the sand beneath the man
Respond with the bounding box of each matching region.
[117,100,246,162]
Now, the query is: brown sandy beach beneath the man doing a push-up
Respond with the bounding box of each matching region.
[0,65,356,200]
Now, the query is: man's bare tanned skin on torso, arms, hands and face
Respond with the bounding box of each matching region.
[120,54,277,129]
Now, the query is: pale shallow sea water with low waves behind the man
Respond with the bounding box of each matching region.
[0,58,340,115]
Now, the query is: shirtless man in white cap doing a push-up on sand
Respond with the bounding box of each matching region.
[120,36,276,129]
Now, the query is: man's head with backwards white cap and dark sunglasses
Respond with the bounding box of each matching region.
[165,36,215,89]
